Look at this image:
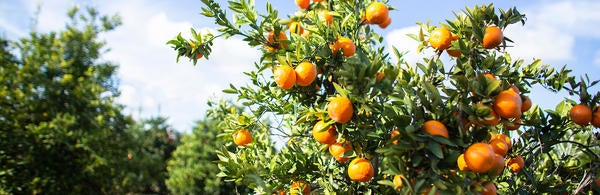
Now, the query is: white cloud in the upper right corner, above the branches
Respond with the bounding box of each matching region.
[505,1,600,64]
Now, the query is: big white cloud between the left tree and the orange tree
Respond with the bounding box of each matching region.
[90,1,259,131]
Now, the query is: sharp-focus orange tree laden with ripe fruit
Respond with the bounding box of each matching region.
[168,0,600,194]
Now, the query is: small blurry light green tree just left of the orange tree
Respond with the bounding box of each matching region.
[167,102,251,194]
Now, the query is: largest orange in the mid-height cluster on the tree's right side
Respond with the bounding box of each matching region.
[494,89,523,118]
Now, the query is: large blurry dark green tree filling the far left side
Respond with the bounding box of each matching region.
[0,8,178,194]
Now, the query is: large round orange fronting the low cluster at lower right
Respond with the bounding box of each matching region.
[465,142,495,173]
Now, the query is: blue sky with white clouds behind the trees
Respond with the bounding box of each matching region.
[0,0,600,132]
